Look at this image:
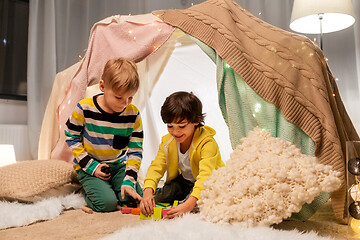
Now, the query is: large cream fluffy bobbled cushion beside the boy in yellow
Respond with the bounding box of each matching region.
[199,127,341,226]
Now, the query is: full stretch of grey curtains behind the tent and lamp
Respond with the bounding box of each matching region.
[28,0,360,159]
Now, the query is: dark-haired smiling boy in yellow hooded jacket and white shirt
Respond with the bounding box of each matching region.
[140,92,224,218]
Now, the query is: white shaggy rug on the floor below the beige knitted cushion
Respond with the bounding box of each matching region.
[0,194,86,229]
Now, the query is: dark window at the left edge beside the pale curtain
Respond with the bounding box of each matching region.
[0,0,29,100]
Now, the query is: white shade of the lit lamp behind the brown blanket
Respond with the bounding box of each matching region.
[290,0,355,34]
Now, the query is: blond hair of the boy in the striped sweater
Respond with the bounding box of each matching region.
[101,58,140,91]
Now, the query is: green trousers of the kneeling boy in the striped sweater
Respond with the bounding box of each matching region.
[77,163,143,212]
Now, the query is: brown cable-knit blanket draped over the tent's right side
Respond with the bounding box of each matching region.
[153,0,359,222]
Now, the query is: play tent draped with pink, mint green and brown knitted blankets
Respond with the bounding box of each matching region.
[39,0,359,222]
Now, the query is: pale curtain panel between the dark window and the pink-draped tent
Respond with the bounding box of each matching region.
[27,1,56,159]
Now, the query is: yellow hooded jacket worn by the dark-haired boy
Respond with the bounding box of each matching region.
[144,126,225,199]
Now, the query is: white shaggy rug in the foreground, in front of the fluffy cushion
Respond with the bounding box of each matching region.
[101,214,334,240]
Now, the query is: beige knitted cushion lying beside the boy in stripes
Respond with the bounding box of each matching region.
[0,160,80,202]
